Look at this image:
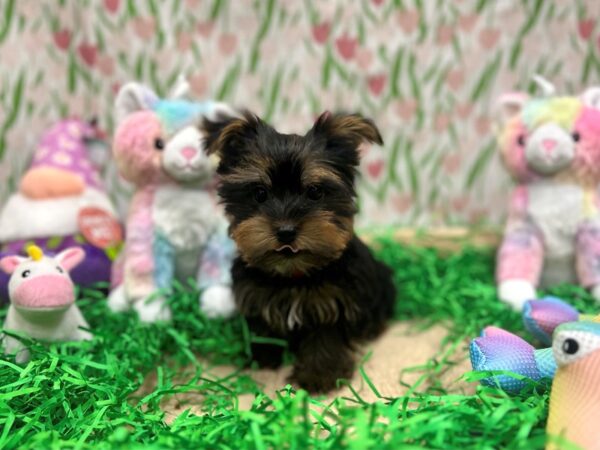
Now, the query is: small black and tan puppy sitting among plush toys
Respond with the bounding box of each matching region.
[203,112,395,392]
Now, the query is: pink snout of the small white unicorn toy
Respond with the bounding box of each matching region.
[11,275,75,308]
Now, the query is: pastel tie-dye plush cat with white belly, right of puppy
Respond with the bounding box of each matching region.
[496,78,600,310]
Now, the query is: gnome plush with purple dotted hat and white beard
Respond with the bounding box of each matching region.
[0,119,122,301]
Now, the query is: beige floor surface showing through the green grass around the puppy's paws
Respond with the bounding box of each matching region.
[151,322,475,422]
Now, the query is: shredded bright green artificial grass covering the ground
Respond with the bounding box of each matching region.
[0,238,594,450]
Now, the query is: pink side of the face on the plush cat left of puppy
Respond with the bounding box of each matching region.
[113,111,163,186]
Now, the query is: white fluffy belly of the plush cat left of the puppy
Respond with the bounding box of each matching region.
[152,185,218,249]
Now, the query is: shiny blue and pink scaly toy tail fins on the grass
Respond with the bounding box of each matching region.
[470,297,600,392]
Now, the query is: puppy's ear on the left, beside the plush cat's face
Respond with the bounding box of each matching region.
[201,111,262,157]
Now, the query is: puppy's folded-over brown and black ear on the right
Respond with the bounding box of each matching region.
[309,111,383,150]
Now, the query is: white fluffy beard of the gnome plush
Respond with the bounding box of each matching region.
[0,188,116,242]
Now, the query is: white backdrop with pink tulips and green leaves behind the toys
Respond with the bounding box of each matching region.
[0,0,600,225]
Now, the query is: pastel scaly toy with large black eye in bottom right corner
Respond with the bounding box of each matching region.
[546,322,600,450]
